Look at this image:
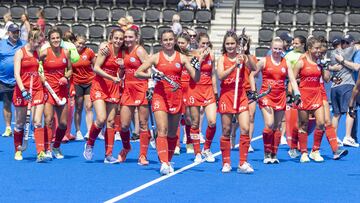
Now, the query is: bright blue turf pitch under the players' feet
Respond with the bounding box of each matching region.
[0,104,360,202]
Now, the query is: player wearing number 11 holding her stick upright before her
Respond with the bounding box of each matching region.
[217,31,255,173]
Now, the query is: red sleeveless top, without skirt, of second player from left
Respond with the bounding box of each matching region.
[43,47,68,92]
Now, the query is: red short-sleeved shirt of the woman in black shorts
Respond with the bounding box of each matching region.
[72,47,95,85]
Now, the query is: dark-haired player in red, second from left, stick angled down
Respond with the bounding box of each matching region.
[40,27,72,159]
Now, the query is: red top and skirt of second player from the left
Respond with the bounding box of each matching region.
[43,47,69,105]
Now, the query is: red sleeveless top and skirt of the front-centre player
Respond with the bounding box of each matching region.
[152,51,183,114]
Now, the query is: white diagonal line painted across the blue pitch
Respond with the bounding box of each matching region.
[105,135,262,203]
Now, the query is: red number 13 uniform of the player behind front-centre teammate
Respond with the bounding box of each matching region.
[186,54,216,106]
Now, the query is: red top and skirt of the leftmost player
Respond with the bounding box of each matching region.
[12,47,44,107]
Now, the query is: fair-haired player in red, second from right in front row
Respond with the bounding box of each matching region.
[254,38,300,164]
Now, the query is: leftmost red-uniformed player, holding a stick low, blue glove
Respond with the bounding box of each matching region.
[13,29,45,162]
